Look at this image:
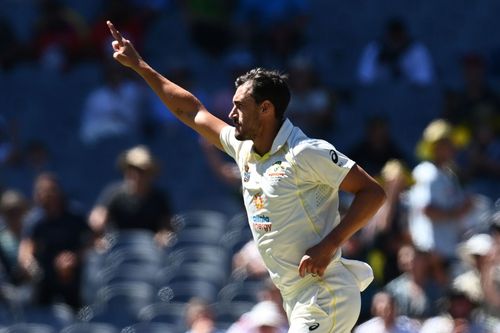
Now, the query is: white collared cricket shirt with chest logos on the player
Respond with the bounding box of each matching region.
[220,120,354,294]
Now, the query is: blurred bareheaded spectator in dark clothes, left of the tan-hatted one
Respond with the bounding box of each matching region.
[19,173,91,309]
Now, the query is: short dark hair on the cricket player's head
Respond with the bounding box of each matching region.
[235,68,290,119]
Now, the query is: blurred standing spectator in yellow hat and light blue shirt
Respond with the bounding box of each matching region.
[408,119,474,274]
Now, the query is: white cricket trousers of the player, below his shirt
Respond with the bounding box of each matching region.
[283,258,373,333]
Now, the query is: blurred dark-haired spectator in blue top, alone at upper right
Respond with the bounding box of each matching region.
[358,18,434,86]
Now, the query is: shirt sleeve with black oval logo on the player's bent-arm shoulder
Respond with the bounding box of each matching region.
[295,140,355,188]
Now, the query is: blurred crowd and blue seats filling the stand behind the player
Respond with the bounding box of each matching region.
[0,0,500,333]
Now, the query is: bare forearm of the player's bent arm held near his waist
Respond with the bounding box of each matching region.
[324,185,385,255]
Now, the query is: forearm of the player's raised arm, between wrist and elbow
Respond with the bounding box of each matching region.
[134,60,203,127]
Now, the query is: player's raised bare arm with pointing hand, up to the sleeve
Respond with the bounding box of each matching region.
[107,21,228,149]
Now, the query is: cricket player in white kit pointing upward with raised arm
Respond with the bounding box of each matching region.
[108,22,385,333]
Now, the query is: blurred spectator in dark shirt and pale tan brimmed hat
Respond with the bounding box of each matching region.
[89,146,173,246]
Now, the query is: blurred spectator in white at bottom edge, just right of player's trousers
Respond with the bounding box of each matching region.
[354,291,420,333]
